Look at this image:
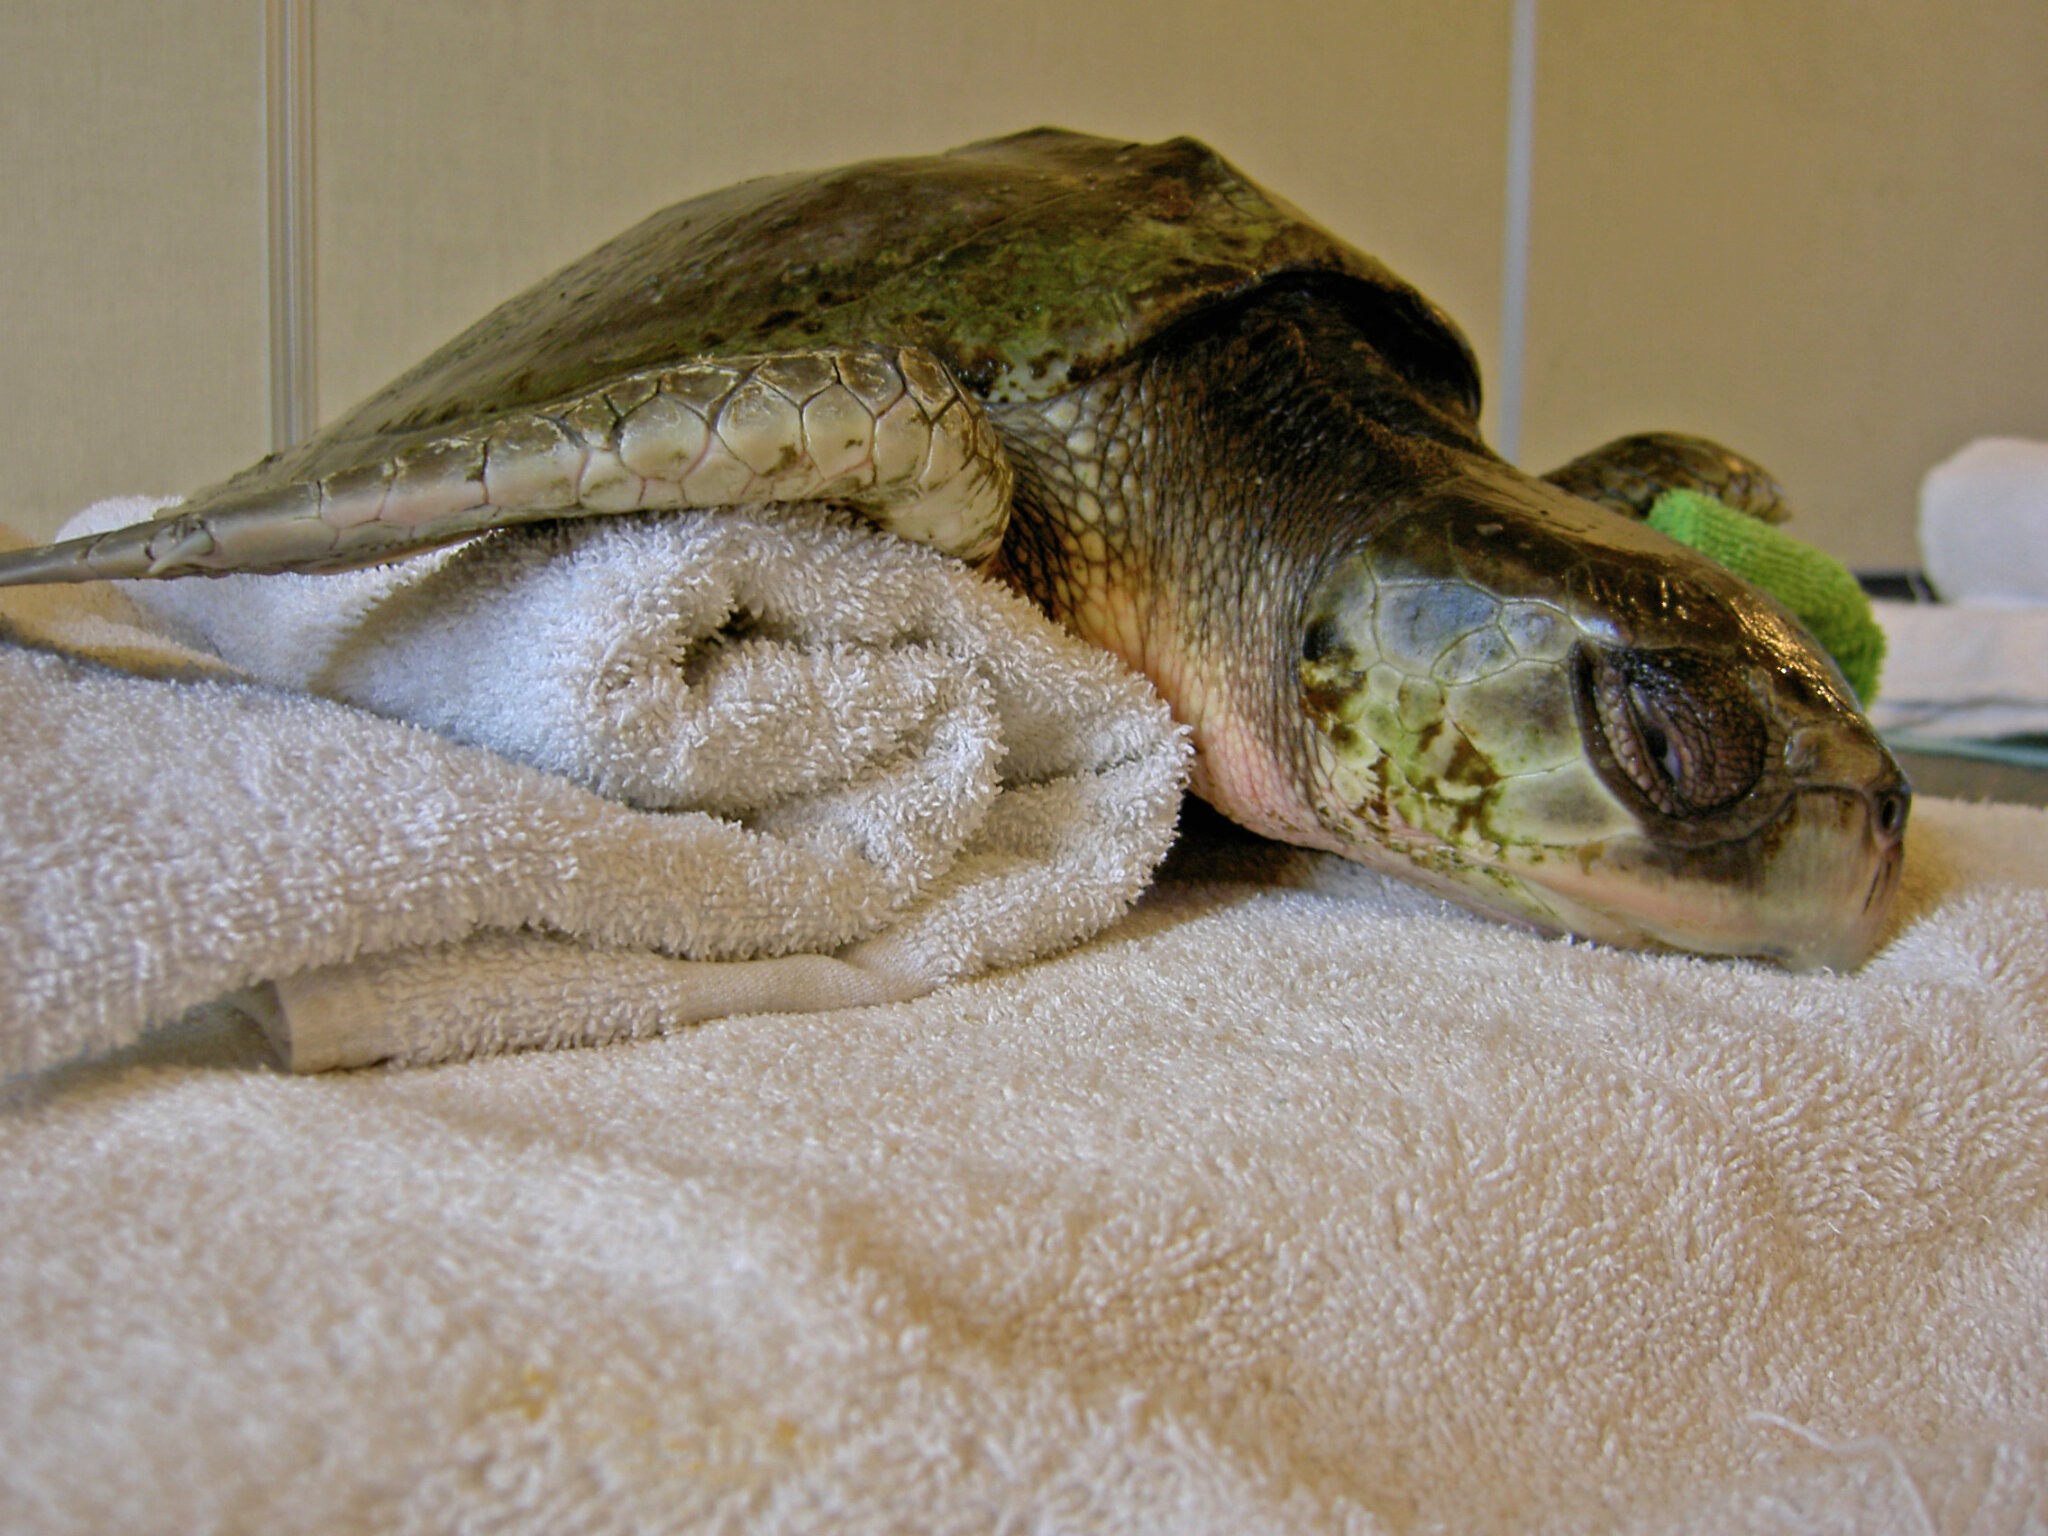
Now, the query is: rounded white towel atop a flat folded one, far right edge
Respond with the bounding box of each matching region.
[1919,438,2048,604]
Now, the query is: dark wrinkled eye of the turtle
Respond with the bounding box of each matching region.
[1589,651,1767,817]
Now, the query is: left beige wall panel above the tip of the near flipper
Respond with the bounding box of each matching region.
[0,0,268,532]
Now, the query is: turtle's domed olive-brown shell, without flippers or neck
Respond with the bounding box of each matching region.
[199,129,1479,507]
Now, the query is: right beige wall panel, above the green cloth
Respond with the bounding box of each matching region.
[1522,0,2048,567]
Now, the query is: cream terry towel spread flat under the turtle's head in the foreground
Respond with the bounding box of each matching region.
[0,801,2048,1536]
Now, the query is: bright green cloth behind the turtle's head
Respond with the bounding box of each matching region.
[1649,492,1884,709]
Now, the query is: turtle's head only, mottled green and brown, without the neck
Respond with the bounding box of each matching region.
[1298,459,1909,969]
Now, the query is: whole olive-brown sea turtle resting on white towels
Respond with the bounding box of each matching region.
[0,129,1909,967]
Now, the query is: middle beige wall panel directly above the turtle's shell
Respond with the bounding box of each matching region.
[315,0,1507,434]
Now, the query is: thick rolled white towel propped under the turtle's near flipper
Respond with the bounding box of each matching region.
[0,502,1188,1071]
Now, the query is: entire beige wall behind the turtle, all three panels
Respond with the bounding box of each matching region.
[0,0,2048,565]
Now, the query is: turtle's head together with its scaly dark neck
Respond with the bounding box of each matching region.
[995,289,1907,967]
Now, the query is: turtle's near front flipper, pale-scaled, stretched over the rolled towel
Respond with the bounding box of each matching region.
[0,346,1012,586]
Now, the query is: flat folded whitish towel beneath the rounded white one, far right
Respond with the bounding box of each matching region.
[1870,602,2048,739]
